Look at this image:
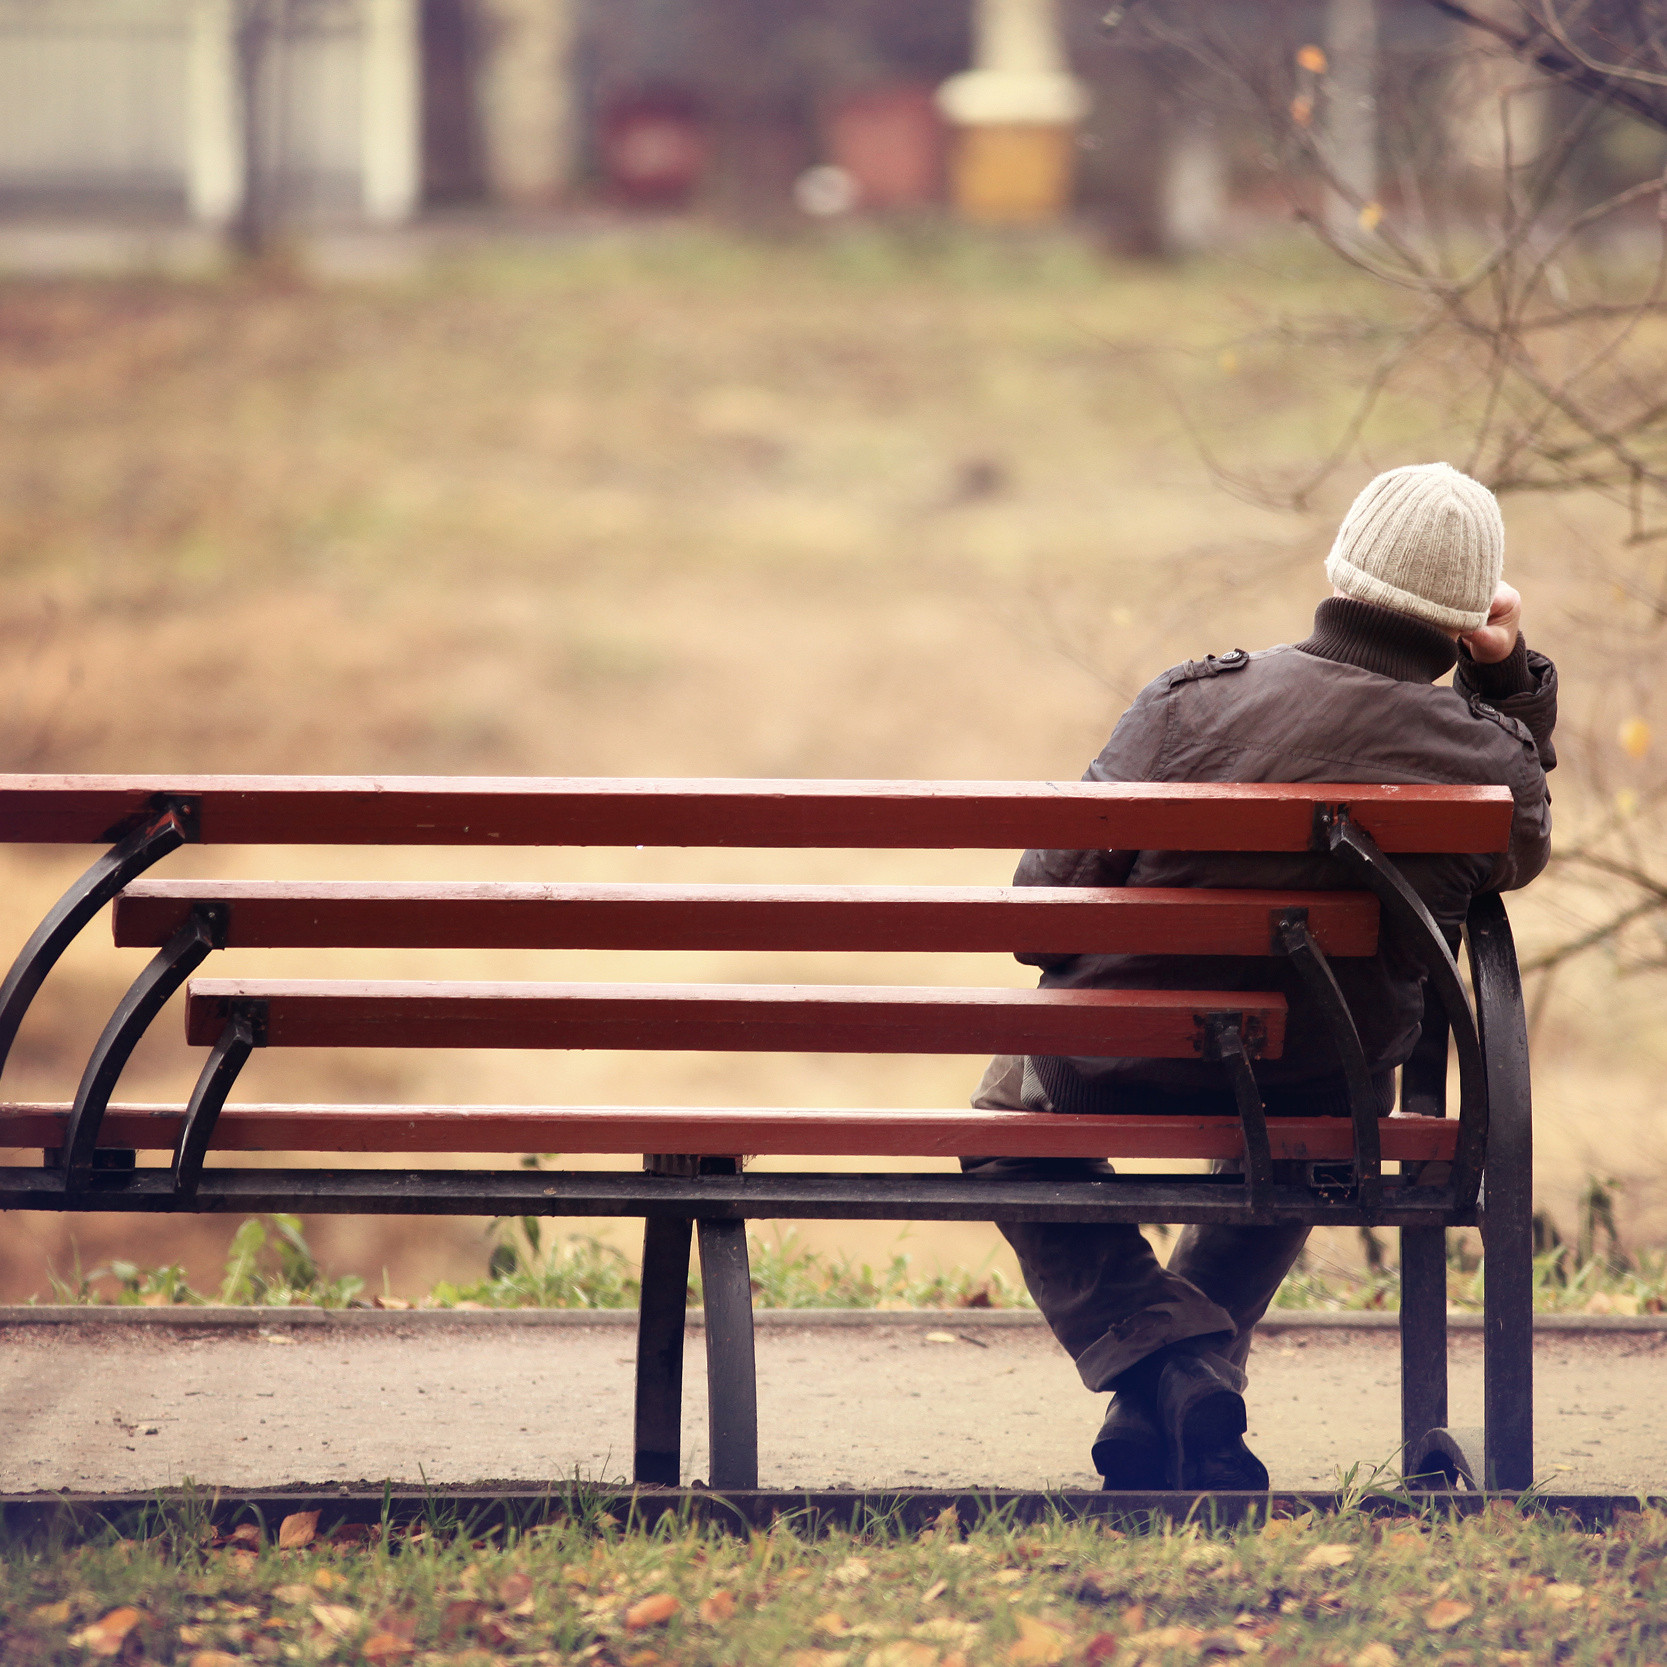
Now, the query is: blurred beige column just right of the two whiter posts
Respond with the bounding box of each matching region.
[478,0,573,205]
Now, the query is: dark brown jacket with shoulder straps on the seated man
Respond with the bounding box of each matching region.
[1014,598,1557,1112]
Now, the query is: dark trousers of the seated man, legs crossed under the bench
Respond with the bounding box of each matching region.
[960,1055,1309,1390]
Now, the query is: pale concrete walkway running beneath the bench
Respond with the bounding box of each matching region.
[0,1310,1667,1494]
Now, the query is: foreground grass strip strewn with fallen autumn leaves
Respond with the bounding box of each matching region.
[0,1500,1667,1667]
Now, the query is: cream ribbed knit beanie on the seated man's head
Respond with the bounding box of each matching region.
[1325,463,1505,630]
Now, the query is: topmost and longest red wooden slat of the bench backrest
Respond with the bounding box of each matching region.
[0,775,1512,852]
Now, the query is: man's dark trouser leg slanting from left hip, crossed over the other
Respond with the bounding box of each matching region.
[960,1057,1240,1390]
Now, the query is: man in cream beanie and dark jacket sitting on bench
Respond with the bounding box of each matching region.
[964,463,1557,1489]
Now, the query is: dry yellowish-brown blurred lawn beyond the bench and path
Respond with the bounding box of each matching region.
[0,228,1667,1297]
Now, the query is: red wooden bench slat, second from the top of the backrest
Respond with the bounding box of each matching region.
[115,880,1377,955]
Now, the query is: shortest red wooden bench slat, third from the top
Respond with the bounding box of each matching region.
[185,979,1285,1059]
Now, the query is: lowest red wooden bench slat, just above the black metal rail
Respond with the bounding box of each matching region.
[0,1105,1459,1162]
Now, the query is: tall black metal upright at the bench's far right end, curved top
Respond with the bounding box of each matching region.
[1465,894,1534,1487]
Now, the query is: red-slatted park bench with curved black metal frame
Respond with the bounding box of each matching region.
[0,775,1532,1489]
